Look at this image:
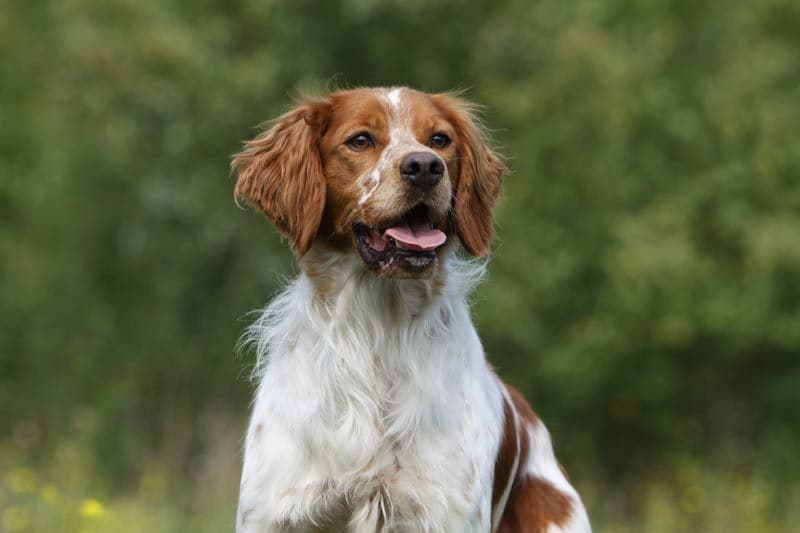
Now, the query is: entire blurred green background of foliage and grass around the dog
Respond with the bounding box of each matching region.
[0,0,800,532]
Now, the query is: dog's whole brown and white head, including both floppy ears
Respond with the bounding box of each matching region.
[233,88,507,278]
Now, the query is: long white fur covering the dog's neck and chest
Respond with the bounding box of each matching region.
[237,256,503,533]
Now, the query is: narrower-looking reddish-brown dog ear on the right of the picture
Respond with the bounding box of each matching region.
[438,95,508,256]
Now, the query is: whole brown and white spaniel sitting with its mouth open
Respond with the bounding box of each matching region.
[232,88,591,533]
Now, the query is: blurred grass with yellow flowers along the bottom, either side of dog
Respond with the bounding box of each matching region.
[0,434,800,533]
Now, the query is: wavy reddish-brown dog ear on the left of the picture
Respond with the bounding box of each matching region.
[231,100,330,256]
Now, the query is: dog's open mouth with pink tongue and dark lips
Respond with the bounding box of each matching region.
[353,204,447,272]
